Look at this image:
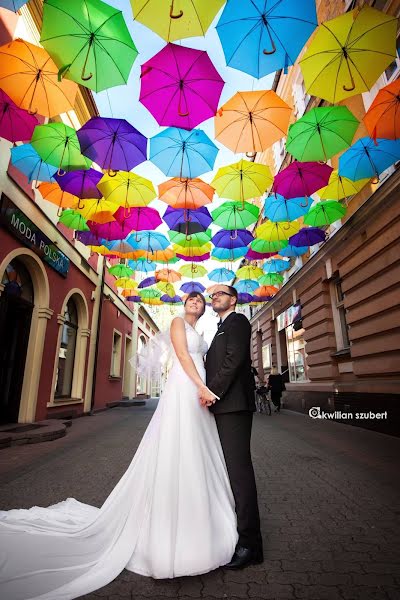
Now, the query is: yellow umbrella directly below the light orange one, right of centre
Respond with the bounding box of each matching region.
[211,159,273,207]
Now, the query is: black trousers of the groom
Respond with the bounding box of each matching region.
[215,411,262,550]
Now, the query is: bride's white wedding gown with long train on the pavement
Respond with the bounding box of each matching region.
[0,321,238,600]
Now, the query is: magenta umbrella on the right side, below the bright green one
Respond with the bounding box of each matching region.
[273,160,333,198]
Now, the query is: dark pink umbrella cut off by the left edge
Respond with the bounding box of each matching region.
[0,90,39,142]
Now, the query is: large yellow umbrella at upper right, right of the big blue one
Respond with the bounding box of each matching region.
[300,5,397,104]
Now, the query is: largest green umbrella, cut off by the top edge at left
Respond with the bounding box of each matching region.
[40,0,138,92]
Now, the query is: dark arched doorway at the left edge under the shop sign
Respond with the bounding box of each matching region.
[0,258,35,423]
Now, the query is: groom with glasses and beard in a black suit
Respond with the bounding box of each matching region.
[200,285,264,569]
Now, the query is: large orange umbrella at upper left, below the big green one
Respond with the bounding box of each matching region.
[0,39,78,117]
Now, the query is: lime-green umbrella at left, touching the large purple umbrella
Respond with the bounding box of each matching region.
[31,123,92,175]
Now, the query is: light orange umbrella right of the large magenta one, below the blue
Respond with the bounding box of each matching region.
[214,90,292,154]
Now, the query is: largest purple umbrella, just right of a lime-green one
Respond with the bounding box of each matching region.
[77,117,147,175]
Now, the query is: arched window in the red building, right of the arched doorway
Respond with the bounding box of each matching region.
[54,298,78,398]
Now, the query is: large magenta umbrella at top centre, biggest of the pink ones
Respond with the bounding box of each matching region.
[139,44,224,129]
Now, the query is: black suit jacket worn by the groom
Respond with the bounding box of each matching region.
[206,312,256,414]
